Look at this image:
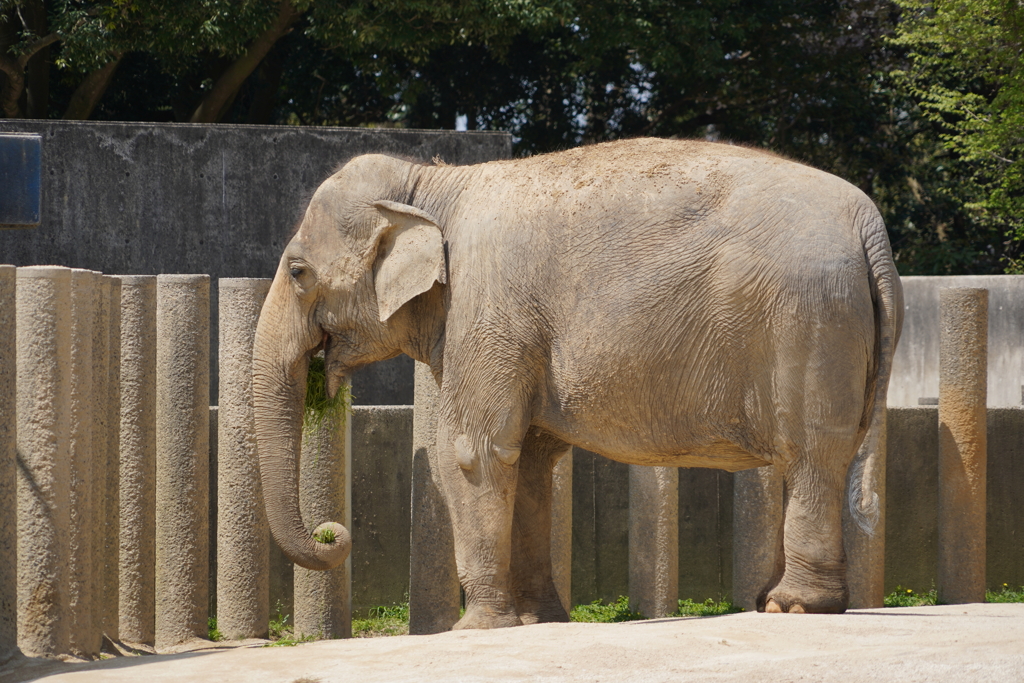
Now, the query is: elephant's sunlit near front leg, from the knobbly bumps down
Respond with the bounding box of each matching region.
[438,428,521,630]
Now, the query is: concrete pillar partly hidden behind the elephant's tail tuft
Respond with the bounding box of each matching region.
[843,411,888,609]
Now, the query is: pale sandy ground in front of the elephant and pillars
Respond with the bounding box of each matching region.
[0,604,1024,683]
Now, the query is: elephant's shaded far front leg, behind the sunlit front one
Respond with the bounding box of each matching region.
[512,428,569,624]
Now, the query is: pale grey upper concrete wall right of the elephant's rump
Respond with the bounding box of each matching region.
[889,275,1024,408]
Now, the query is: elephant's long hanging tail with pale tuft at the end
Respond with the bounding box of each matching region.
[847,205,903,536]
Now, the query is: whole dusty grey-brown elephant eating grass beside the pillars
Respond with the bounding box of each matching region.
[253,138,903,629]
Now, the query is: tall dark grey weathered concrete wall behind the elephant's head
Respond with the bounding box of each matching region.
[0,119,512,404]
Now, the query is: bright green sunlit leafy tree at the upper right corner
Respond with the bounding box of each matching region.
[895,0,1024,272]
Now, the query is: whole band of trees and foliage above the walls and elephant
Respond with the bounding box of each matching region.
[0,0,1024,274]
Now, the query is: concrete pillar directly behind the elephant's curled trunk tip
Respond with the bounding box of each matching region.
[295,411,352,638]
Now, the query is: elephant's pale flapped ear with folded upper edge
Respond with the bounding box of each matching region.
[374,201,447,323]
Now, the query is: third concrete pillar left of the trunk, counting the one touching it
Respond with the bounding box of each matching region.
[118,275,157,645]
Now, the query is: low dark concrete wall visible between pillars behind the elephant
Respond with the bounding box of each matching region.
[352,407,1024,612]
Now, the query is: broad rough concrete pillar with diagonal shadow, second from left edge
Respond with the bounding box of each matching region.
[16,266,71,657]
